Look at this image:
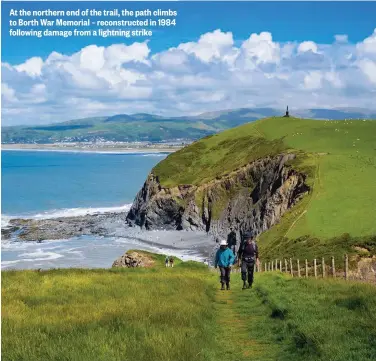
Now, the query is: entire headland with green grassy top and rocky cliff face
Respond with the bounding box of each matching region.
[128,117,376,258]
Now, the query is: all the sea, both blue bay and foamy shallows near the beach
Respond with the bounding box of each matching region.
[1,150,209,269]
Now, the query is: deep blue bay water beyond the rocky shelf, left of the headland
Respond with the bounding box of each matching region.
[1,151,166,219]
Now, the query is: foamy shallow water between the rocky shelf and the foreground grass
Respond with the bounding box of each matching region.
[1,232,209,269]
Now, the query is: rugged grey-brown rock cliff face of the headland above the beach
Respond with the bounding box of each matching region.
[127,154,309,236]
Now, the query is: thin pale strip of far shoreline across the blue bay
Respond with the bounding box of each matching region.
[1,143,183,154]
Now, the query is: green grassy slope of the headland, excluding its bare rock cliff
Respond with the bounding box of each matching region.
[153,117,376,256]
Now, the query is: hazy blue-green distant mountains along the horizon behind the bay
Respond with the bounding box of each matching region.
[2,108,376,144]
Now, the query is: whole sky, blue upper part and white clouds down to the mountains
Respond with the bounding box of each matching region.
[1,1,376,125]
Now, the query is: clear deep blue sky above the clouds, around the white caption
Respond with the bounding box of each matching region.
[2,1,376,64]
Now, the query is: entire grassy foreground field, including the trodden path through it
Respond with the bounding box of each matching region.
[2,256,376,361]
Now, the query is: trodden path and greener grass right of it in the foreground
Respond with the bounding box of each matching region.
[216,273,376,361]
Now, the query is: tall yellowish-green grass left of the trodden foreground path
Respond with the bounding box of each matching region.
[2,253,215,361]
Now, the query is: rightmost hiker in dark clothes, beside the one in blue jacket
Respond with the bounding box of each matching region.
[238,232,259,290]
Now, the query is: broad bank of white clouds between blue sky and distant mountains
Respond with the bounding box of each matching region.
[2,29,376,125]
